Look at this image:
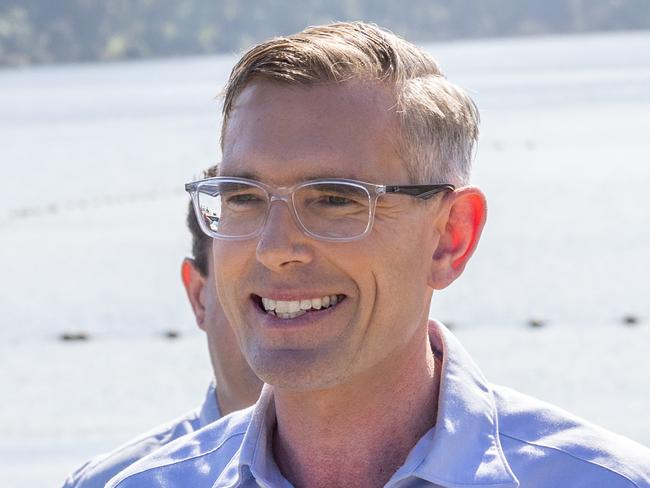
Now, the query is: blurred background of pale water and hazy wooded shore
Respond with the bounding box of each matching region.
[0,0,650,487]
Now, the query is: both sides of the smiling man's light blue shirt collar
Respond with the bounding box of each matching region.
[214,322,519,488]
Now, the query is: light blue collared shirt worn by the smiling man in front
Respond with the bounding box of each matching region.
[107,323,650,488]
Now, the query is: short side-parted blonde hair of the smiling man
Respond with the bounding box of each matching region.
[221,22,479,185]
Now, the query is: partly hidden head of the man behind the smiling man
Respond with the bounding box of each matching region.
[181,165,261,414]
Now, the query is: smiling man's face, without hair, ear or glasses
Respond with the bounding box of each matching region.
[213,82,438,390]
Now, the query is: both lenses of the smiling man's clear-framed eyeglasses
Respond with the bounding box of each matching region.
[197,181,371,239]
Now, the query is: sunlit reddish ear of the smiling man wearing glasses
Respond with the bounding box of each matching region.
[429,186,487,290]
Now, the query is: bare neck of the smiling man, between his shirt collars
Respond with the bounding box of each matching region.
[273,324,439,487]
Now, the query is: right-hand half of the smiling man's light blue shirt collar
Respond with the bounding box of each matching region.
[393,321,519,488]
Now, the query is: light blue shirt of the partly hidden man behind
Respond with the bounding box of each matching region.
[62,382,221,488]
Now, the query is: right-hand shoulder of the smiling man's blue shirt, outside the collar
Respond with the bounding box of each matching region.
[492,385,650,488]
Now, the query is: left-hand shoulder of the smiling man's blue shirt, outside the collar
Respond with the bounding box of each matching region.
[106,407,253,488]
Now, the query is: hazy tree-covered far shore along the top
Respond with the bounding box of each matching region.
[0,0,650,66]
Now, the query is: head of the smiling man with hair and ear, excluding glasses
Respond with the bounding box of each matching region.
[205,23,485,390]
